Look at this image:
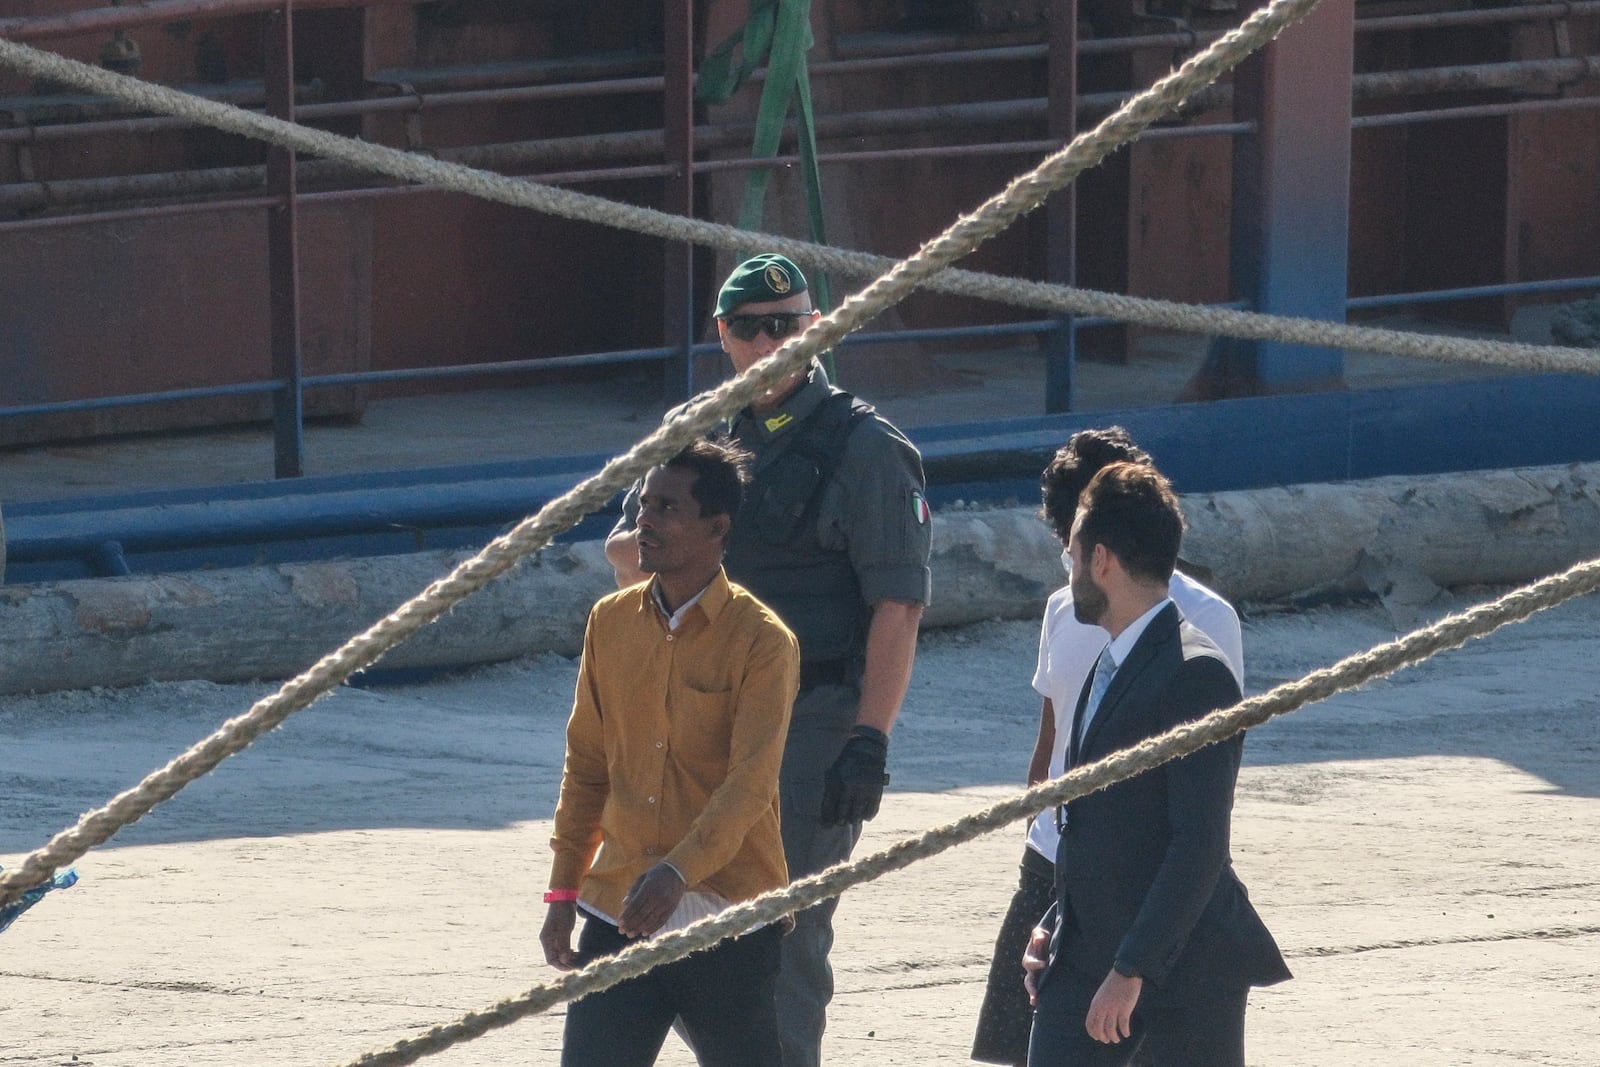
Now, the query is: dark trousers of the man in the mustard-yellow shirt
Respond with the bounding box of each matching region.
[562,915,782,1067]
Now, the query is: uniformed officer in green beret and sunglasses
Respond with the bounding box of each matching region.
[606,253,930,1067]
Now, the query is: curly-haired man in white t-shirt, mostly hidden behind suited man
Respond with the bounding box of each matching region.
[973,426,1245,1065]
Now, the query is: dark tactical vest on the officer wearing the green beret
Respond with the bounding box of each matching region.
[723,392,872,681]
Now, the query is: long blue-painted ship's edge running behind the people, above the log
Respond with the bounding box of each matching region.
[6,374,1600,582]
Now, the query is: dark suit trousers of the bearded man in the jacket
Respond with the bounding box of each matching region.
[1027,965,1250,1067]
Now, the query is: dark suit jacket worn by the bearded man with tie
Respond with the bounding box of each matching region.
[1046,603,1290,1000]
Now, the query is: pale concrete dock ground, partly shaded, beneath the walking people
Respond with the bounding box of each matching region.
[0,590,1600,1067]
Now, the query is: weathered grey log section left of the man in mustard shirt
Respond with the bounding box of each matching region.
[0,542,613,693]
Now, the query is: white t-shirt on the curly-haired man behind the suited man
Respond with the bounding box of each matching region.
[1027,571,1245,862]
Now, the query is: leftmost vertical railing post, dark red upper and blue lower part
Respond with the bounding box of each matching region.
[266,0,306,478]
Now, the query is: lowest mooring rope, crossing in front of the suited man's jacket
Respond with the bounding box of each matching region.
[337,560,1600,1067]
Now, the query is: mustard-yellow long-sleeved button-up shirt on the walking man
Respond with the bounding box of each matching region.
[550,571,800,915]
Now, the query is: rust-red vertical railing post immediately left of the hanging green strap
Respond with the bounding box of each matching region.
[662,0,694,403]
